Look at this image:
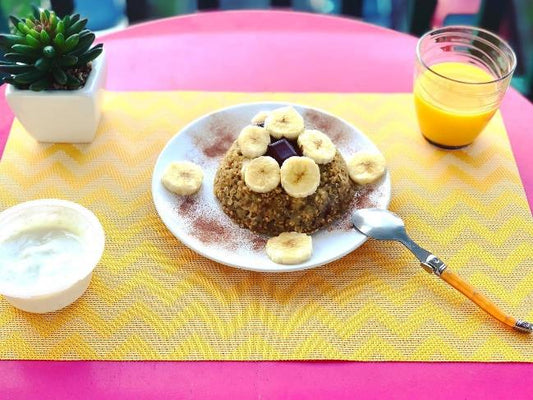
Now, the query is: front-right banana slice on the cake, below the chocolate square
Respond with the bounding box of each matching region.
[280,157,320,197]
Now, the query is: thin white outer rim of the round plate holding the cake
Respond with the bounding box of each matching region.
[151,101,392,273]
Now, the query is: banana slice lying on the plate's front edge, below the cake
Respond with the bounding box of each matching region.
[266,232,313,264]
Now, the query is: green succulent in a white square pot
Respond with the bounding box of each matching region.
[0,9,106,143]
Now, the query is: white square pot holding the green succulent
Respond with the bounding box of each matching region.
[6,52,107,143]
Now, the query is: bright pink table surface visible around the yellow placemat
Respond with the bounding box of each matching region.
[0,11,533,400]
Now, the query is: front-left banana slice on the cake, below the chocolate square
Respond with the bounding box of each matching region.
[244,156,280,193]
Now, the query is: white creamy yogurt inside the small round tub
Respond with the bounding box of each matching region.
[0,225,85,291]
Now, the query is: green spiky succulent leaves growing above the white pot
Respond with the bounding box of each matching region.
[0,8,103,91]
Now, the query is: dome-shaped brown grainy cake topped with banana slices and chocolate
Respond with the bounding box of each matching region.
[214,107,358,236]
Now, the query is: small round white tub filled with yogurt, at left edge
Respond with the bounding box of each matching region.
[0,199,105,313]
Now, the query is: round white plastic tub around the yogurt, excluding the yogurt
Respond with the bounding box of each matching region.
[0,199,105,313]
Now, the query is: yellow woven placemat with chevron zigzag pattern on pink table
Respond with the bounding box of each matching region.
[0,92,533,362]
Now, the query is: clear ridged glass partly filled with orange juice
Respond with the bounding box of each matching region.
[413,26,516,149]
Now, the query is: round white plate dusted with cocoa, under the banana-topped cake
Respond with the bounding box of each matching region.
[152,103,391,272]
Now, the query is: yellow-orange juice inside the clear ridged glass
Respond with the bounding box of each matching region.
[414,62,499,147]
